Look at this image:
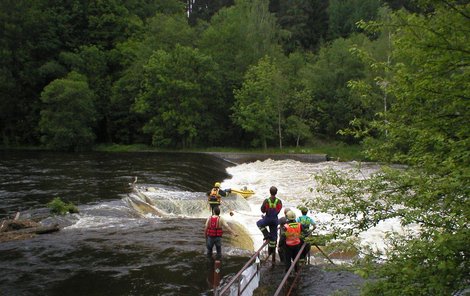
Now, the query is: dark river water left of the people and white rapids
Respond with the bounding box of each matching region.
[0,151,250,296]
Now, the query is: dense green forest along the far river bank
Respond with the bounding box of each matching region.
[0,0,426,151]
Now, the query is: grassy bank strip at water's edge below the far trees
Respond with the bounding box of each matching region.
[93,143,365,161]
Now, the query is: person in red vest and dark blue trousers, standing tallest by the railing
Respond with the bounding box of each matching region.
[256,186,282,255]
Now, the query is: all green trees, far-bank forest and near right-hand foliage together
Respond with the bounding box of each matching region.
[0,0,470,295]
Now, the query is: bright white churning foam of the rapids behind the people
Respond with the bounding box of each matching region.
[222,159,403,250]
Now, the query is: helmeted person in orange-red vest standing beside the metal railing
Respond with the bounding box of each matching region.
[282,211,303,272]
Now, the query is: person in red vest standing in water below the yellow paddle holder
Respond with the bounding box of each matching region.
[204,207,238,259]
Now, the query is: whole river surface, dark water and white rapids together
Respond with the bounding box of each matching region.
[0,151,386,296]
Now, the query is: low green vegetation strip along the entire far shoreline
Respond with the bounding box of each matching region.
[0,143,367,162]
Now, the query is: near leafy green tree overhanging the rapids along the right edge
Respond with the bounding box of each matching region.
[316,1,470,295]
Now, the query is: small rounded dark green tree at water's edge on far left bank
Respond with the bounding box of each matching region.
[39,72,96,151]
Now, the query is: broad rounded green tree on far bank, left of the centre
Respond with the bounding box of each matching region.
[135,45,219,148]
